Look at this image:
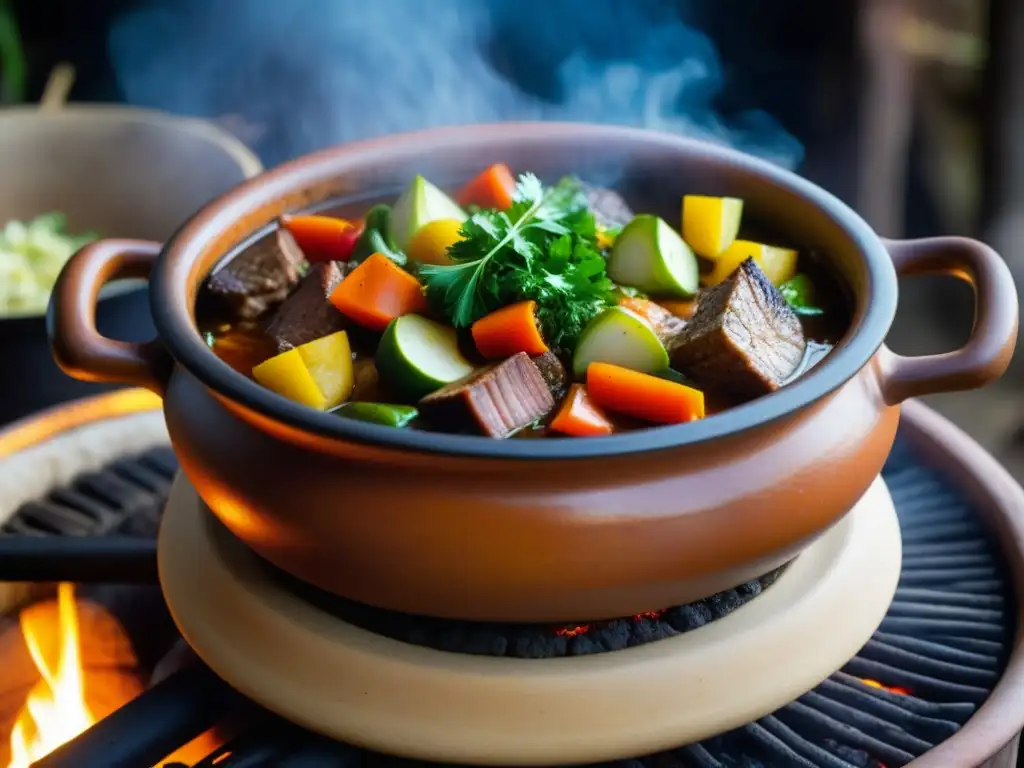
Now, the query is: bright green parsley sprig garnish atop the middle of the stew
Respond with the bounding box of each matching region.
[419,173,614,349]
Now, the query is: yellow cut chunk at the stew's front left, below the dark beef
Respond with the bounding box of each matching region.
[253,331,354,411]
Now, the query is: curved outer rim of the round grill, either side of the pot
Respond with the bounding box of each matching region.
[0,390,1024,768]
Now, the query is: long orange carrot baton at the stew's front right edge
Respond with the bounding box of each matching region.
[587,362,705,424]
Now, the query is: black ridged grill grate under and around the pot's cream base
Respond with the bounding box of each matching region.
[4,441,1015,768]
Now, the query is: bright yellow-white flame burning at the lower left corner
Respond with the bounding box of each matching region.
[7,584,96,768]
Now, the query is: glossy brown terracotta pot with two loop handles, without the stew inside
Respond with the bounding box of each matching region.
[51,124,1018,621]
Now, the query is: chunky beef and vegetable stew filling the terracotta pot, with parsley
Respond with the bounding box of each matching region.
[198,164,848,438]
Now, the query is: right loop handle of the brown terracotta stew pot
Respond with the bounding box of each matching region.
[881,238,1018,406]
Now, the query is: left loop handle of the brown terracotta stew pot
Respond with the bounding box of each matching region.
[46,240,172,395]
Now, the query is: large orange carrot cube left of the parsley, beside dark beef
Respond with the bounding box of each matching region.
[331,253,427,331]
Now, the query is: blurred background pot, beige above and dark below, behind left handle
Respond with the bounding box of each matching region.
[0,105,262,424]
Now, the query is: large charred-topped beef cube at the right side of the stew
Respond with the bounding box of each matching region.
[672,259,807,398]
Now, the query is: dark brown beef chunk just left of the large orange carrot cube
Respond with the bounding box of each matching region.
[266,261,348,352]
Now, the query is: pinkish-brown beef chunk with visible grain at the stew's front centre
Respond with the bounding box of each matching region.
[420,352,555,438]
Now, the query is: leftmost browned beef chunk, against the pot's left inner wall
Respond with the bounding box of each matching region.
[207,229,305,319]
